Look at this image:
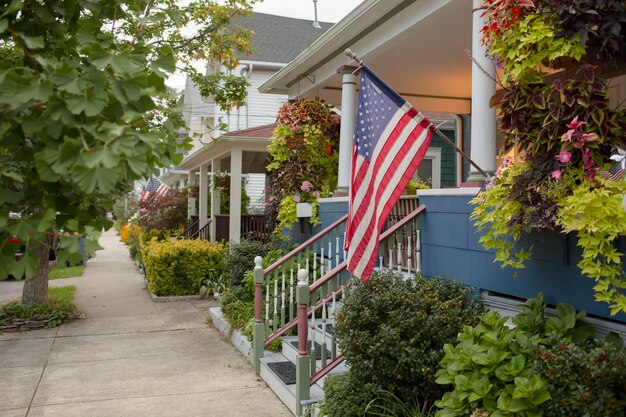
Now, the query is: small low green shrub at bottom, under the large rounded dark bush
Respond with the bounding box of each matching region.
[320,372,382,417]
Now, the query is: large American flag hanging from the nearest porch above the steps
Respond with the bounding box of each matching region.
[344,66,435,281]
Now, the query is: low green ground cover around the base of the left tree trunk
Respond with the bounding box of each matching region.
[0,285,78,327]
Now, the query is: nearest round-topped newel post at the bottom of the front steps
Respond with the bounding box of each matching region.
[296,269,311,417]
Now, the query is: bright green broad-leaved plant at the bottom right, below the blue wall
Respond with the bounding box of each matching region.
[436,295,593,417]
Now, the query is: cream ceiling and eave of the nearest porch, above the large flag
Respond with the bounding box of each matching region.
[260,0,472,113]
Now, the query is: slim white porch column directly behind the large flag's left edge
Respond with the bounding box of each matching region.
[337,65,357,194]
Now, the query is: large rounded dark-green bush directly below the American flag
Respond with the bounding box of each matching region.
[336,271,483,404]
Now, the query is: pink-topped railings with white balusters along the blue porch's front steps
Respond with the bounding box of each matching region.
[253,198,425,415]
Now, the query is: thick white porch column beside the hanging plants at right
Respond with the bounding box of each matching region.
[467,0,496,182]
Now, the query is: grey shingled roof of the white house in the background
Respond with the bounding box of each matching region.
[234,13,333,64]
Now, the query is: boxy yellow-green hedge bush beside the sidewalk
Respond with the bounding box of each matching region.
[144,240,226,295]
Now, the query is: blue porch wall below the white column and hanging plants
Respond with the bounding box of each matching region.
[420,195,626,322]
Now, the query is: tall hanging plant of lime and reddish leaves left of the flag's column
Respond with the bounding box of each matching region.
[267,99,339,232]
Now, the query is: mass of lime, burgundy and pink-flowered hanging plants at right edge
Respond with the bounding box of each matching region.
[472,0,626,314]
